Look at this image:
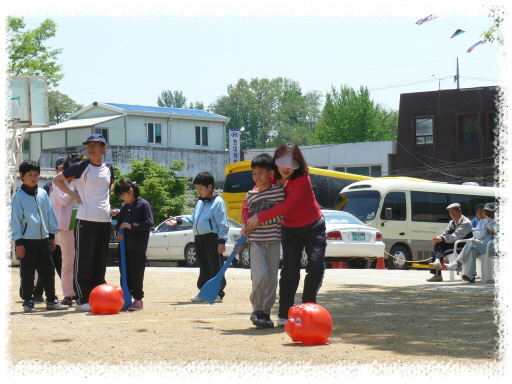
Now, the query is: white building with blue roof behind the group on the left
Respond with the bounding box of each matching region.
[23,102,229,180]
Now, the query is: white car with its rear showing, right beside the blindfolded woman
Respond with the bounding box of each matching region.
[237,209,385,268]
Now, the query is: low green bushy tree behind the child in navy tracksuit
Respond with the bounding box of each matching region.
[110,159,187,224]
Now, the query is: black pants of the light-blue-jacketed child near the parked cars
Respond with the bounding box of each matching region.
[194,233,226,299]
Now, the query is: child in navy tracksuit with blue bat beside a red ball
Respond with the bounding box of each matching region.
[112,179,153,311]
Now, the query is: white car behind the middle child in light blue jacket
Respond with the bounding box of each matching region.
[146,216,242,267]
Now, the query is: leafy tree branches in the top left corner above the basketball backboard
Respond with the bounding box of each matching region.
[7,16,64,88]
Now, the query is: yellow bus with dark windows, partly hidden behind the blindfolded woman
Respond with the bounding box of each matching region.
[222,160,372,223]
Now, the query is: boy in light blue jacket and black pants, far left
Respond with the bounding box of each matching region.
[11,160,69,312]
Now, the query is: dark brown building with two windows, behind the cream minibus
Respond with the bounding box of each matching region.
[393,87,498,185]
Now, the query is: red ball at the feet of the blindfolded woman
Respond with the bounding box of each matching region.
[284,303,332,345]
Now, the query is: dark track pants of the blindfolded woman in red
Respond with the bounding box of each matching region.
[278,217,327,319]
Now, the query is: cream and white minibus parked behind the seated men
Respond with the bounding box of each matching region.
[339,179,497,269]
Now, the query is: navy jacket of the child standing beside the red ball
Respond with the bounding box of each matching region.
[115,197,153,253]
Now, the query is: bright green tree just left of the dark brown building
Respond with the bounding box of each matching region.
[314,85,398,144]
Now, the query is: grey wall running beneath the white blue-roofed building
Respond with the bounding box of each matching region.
[41,145,229,181]
